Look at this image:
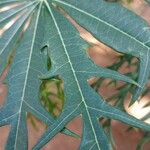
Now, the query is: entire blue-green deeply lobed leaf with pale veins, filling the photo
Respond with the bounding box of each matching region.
[0,0,150,150]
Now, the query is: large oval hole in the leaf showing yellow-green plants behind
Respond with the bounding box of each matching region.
[40,78,64,118]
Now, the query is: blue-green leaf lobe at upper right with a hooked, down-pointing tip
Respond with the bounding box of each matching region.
[54,0,150,101]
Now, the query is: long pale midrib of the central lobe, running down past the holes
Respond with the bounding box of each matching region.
[45,1,100,150]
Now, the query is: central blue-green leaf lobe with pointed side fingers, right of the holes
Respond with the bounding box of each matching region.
[33,2,150,150]
